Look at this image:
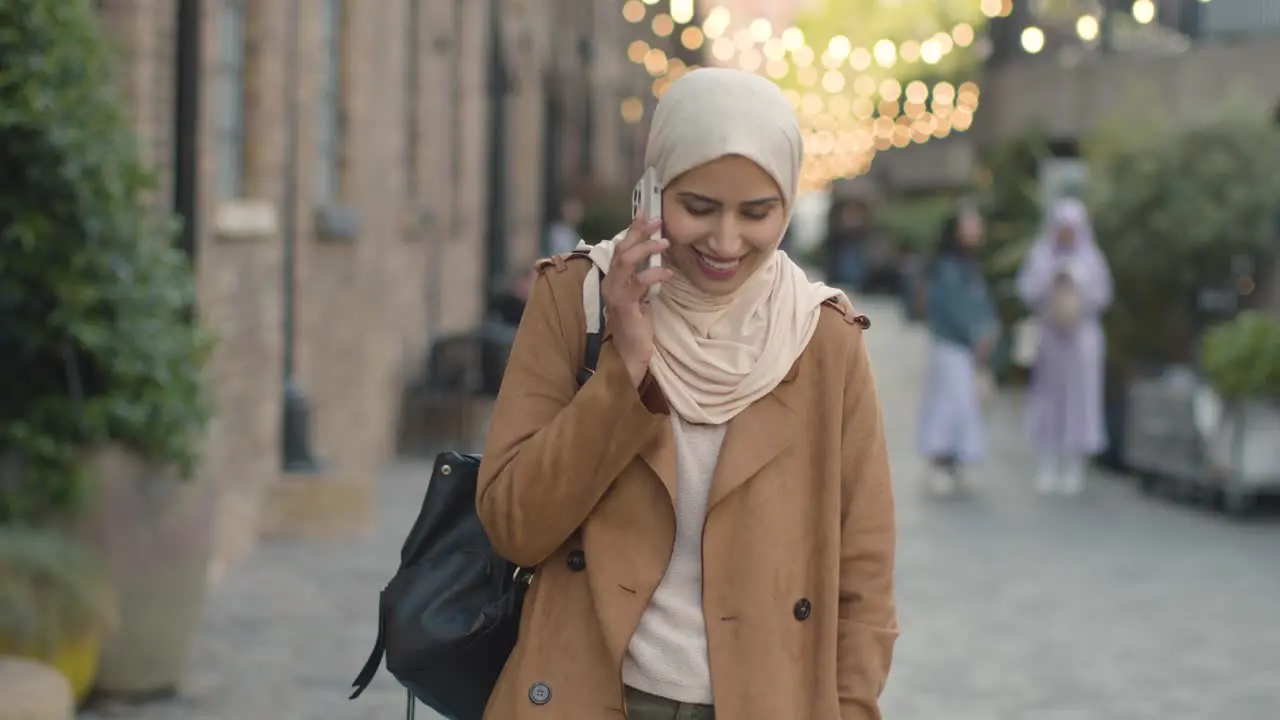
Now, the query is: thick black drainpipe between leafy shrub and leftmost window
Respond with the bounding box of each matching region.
[173,0,201,265]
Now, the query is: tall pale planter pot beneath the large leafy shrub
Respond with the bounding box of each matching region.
[78,446,214,698]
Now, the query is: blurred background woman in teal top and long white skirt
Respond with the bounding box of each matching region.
[919,208,1000,495]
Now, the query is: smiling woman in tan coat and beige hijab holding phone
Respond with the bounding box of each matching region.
[476,68,897,720]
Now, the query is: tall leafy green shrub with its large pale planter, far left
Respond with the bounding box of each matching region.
[0,0,212,693]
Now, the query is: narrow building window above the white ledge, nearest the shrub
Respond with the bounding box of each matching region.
[216,0,244,200]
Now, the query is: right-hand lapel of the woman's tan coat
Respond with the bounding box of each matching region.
[707,361,799,514]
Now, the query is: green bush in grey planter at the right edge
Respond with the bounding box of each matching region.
[1199,310,1280,512]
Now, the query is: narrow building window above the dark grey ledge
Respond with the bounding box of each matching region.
[315,0,343,204]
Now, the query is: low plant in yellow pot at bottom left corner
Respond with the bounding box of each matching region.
[0,525,116,705]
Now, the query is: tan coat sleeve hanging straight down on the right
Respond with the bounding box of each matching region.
[836,331,897,720]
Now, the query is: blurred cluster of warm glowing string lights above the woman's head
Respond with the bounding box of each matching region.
[620,0,983,190]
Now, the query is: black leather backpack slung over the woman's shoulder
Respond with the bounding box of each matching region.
[351,257,604,720]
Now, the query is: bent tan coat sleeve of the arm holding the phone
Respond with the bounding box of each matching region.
[476,269,664,568]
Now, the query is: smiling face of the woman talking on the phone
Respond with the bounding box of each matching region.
[662,155,787,295]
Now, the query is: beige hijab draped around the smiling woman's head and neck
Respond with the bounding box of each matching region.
[582,68,849,424]
